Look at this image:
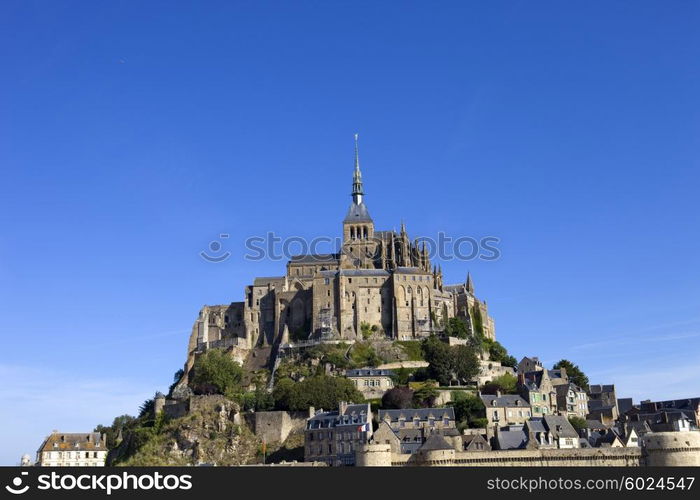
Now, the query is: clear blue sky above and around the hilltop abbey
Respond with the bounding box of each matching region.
[0,1,700,464]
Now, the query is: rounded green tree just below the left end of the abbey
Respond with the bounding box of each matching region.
[191,349,243,398]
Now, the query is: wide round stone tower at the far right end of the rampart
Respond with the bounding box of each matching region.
[642,431,700,467]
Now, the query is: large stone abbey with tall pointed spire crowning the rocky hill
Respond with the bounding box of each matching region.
[191,136,495,349]
